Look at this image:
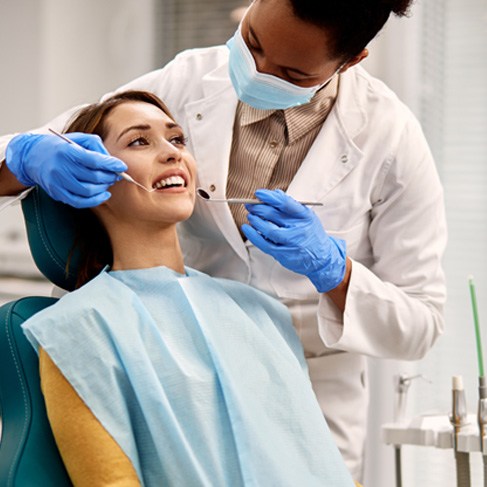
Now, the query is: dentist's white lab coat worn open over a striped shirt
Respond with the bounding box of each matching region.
[0,46,446,478]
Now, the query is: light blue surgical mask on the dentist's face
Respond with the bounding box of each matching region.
[227,27,340,110]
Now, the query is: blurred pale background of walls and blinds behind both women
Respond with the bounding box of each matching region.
[0,0,487,487]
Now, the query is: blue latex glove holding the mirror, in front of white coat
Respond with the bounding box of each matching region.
[242,189,346,293]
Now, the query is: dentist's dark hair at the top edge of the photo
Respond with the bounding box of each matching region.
[285,0,413,61]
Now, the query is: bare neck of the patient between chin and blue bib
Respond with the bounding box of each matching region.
[109,225,184,274]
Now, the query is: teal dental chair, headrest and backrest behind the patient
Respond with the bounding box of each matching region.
[0,188,79,487]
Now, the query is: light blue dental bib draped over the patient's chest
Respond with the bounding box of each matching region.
[24,267,353,487]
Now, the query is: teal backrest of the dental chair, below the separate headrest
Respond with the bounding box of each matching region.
[0,297,71,487]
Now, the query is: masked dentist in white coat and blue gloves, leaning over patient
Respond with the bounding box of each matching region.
[0,0,446,480]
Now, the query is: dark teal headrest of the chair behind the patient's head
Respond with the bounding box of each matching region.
[22,187,80,291]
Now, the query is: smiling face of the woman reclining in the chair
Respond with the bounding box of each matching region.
[103,102,196,224]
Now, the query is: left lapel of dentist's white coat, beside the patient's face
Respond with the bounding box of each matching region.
[185,70,249,265]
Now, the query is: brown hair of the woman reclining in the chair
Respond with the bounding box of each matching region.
[64,90,174,288]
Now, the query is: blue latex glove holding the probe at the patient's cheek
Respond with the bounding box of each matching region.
[6,133,127,208]
